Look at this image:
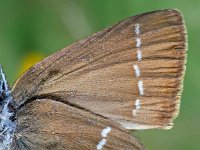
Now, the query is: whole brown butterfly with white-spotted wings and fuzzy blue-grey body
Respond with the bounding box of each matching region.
[0,9,187,150]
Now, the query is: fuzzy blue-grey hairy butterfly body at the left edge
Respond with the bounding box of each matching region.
[0,66,16,149]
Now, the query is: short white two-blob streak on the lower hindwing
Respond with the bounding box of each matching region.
[97,127,112,150]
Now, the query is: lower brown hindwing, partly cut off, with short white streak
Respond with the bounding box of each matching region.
[12,99,143,150]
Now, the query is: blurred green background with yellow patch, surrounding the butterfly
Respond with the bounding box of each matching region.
[0,0,200,150]
